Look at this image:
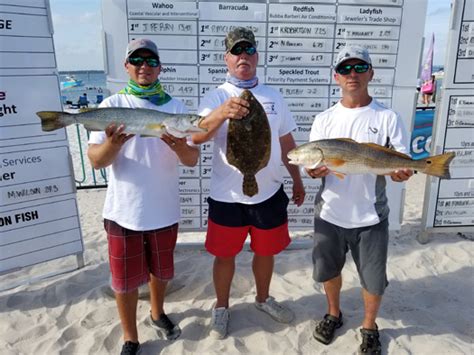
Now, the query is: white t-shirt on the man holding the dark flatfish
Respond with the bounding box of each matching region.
[198,83,296,204]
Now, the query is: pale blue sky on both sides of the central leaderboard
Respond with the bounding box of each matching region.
[49,0,451,71]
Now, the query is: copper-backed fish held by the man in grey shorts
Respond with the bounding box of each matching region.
[288,138,455,179]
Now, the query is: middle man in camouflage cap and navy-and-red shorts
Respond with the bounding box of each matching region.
[193,27,305,339]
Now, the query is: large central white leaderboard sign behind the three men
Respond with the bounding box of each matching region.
[102,0,426,229]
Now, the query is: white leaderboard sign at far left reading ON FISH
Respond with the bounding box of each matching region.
[0,0,83,273]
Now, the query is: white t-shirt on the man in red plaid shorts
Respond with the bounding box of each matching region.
[89,94,187,231]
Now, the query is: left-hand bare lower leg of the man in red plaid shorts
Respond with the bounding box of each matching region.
[115,290,138,343]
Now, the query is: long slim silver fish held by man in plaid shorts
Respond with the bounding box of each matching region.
[36,107,206,138]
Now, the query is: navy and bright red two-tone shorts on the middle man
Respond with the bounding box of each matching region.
[205,187,291,257]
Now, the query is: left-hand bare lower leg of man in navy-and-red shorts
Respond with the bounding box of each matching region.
[213,256,235,308]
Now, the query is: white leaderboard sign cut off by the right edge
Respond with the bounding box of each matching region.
[418,0,474,242]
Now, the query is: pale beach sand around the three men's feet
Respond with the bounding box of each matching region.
[0,175,474,355]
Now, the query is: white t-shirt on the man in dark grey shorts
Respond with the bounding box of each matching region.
[309,99,409,228]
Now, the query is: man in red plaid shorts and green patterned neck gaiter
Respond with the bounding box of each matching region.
[88,39,199,355]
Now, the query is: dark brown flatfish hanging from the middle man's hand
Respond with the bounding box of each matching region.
[226,90,271,197]
